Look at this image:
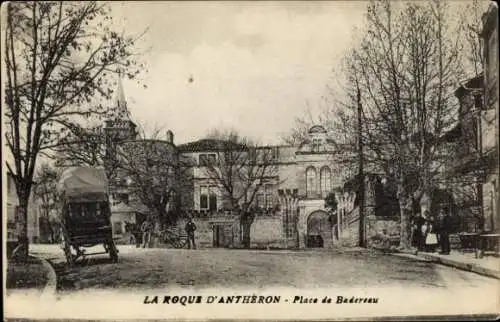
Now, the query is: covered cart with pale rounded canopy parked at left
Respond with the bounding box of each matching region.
[58,167,118,265]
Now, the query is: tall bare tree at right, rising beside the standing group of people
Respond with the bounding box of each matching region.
[346,1,464,248]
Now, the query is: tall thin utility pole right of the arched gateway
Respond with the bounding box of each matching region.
[356,80,366,247]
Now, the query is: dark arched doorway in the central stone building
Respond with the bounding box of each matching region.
[306,210,333,248]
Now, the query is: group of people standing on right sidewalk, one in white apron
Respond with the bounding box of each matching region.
[412,208,452,255]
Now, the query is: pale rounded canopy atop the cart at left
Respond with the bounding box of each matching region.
[57,167,108,201]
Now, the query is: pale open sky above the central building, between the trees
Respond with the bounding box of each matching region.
[112,1,366,144]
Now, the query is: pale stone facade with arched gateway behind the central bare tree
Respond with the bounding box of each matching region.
[177,126,340,248]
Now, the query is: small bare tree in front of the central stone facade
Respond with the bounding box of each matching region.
[203,130,278,248]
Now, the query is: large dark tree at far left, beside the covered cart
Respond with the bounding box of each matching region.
[3,1,145,256]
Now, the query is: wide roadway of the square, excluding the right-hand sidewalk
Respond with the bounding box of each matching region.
[24,245,500,295]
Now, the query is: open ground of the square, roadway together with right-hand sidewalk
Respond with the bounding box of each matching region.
[10,245,500,299]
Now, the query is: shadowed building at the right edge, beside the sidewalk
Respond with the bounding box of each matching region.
[443,5,499,236]
